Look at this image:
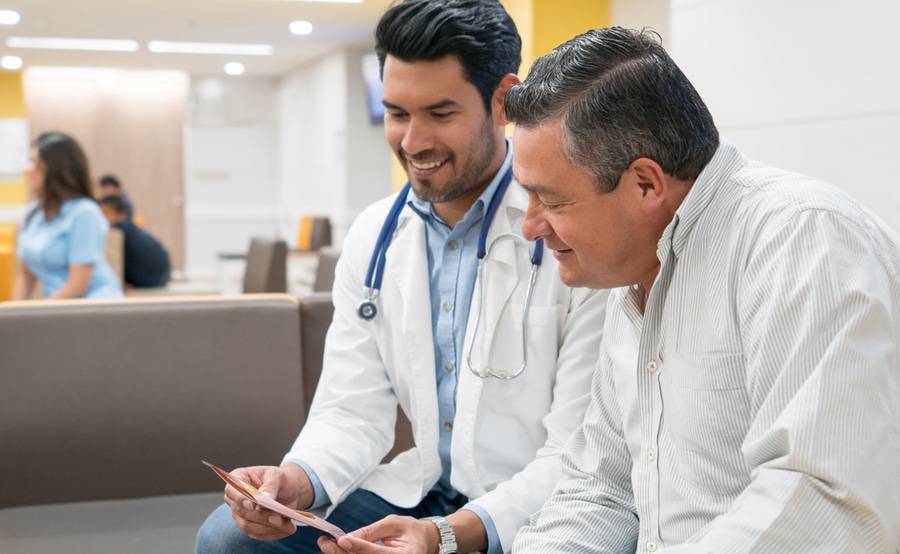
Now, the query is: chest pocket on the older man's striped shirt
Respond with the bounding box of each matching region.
[659,352,750,492]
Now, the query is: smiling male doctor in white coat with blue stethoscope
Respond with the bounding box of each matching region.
[197,0,606,553]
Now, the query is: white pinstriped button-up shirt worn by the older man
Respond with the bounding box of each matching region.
[513,142,900,554]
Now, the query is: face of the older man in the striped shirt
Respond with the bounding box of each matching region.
[513,119,657,288]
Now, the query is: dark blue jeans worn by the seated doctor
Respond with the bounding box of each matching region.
[197,489,468,554]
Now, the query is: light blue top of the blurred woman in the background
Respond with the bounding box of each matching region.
[16,198,122,298]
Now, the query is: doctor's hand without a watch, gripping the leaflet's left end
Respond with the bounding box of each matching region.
[225,463,313,541]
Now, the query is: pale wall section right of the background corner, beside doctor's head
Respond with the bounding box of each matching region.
[279,48,391,245]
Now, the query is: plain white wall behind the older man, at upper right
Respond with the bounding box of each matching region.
[669,0,900,229]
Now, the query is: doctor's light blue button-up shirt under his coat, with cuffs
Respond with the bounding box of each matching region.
[298,140,512,554]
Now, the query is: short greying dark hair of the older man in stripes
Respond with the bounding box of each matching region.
[506,27,719,193]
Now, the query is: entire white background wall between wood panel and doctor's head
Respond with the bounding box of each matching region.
[185,48,391,278]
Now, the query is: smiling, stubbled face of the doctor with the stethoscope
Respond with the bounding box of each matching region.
[384,56,505,202]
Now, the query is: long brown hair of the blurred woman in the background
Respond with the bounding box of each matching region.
[27,132,93,219]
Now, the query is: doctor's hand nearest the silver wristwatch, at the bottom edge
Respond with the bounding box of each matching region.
[318,516,441,554]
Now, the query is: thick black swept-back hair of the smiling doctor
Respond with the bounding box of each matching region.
[375,0,522,112]
